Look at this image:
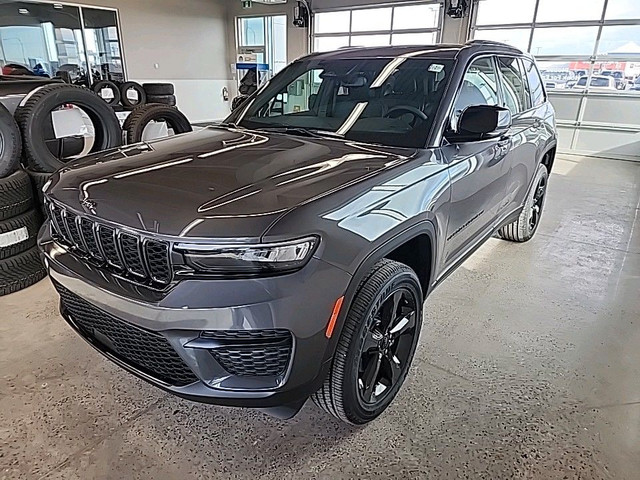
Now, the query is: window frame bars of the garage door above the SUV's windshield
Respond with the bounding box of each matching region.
[310,0,445,52]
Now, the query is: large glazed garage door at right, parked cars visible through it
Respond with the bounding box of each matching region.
[471,0,640,160]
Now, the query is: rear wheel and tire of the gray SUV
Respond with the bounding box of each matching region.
[498,165,549,243]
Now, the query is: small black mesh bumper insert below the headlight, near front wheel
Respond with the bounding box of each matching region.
[202,329,293,377]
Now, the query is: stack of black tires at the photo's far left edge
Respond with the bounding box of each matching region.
[0,105,46,296]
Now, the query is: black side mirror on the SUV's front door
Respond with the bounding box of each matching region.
[456,105,511,141]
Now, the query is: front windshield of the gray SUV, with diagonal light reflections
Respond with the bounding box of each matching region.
[226,56,453,148]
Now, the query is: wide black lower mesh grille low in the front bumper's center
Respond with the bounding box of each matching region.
[55,284,198,387]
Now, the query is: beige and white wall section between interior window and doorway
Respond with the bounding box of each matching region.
[64,0,232,122]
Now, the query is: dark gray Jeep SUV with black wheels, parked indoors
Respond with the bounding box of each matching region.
[39,42,556,424]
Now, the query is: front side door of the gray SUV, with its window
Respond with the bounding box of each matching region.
[442,57,511,269]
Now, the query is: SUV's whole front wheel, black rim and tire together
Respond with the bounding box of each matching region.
[311,258,423,425]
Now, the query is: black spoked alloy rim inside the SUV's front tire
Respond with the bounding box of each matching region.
[358,288,417,407]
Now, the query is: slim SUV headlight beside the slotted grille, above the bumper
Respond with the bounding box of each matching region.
[176,237,319,275]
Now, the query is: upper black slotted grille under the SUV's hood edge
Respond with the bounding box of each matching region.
[49,204,172,285]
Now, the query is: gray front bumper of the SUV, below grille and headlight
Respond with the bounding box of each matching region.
[38,223,351,408]
